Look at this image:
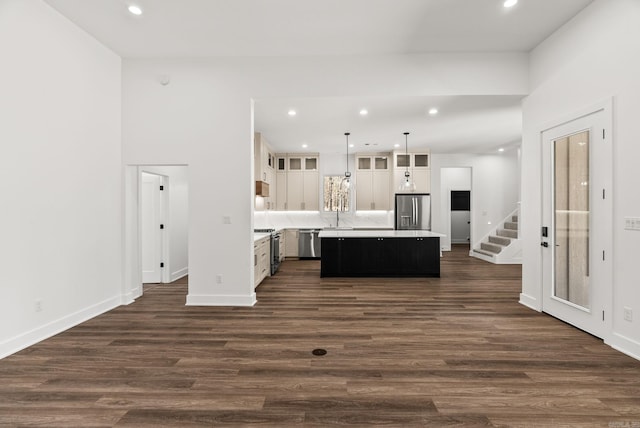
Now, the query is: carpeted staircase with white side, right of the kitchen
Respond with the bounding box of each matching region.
[471,210,522,264]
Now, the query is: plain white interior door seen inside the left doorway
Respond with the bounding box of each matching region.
[140,172,162,283]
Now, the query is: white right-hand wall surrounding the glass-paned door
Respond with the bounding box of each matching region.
[522,0,640,358]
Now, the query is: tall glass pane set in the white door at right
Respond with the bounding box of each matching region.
[553,131,590,309]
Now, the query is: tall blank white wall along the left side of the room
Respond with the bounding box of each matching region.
[0,0,123,357]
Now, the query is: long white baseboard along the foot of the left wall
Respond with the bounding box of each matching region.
[0,296,123,359]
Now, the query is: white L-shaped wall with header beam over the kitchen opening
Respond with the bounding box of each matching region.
[122,54,528,305]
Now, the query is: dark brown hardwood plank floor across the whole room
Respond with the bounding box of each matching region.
[0,249,640,428]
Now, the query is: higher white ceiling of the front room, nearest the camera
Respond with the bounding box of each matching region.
[45,0,592,58]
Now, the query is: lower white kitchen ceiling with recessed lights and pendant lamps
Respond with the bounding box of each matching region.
[255,96,522,153]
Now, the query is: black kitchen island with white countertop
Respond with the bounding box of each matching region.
[319,229,445,277]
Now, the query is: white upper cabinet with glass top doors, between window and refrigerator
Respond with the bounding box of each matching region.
[356,153,391,211]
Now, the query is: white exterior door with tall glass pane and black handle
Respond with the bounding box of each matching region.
[541,110,613,338]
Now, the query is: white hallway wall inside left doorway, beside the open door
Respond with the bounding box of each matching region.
[140,165,189,281]
